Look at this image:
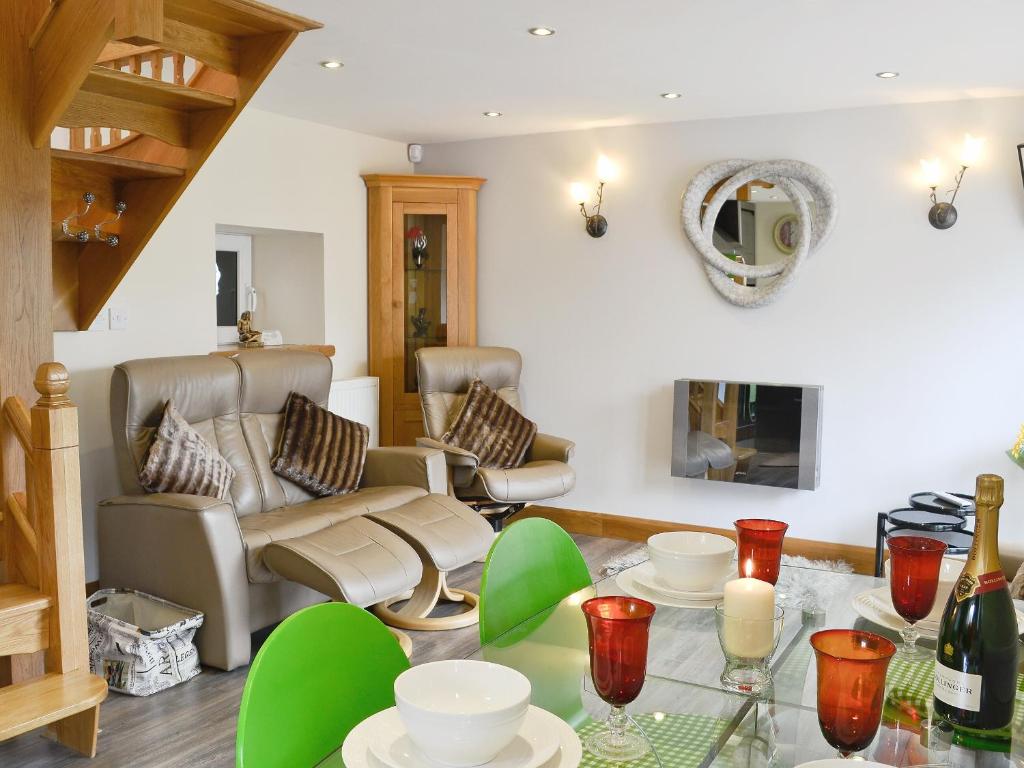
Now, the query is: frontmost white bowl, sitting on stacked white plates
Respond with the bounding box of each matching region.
[394,660,530,768]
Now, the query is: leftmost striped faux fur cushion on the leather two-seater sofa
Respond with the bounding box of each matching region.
[138,400,234,499]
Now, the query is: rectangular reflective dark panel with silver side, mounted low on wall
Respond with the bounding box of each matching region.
[672,379,821,490]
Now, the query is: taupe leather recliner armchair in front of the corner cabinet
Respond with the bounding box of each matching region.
[416,347,575,530]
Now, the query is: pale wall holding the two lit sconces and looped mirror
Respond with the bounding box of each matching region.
[418,99,1024,545]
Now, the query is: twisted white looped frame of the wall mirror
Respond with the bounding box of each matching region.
[682,160,836,307]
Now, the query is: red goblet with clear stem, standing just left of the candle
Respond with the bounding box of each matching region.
[582,595,655,761]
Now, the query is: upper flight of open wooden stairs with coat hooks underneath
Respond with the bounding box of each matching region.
[45,0,319,331]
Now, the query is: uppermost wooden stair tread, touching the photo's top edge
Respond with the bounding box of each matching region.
[164,0,323,37]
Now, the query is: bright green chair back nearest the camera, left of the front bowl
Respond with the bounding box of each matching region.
[236,602,409,768]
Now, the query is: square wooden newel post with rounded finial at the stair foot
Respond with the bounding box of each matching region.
[31,362,89,673]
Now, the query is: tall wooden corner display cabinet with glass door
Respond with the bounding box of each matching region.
[362,174,484,445]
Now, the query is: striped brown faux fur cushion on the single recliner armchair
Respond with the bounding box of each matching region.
[441,379,537,469]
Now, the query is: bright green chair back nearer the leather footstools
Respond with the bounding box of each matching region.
[480,517,593,645]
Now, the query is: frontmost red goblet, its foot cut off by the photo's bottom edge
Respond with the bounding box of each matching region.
[811,630,896,758]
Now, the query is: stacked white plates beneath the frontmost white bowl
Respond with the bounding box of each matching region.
[341,707,583,768]
